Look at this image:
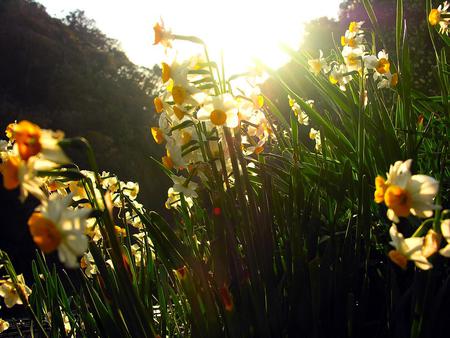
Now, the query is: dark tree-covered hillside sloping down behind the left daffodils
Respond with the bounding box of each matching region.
[0,0,167,213]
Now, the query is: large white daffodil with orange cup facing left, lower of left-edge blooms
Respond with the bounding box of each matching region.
[28,194,90,268]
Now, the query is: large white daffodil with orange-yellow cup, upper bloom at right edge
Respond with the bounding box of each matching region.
[375,160,439,223]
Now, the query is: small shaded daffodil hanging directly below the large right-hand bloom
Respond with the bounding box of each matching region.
[389,224,433,270]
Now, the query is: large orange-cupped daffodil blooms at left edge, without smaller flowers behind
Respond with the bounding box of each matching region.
[0,121,89,267]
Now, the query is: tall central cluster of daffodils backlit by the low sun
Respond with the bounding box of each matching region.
[151,23,273,208]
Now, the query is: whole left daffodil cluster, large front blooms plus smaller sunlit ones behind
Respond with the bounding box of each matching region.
[0,121,150,276]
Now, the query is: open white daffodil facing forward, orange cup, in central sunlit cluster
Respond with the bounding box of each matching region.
[197,94,239,128]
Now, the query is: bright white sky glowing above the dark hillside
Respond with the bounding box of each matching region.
[38,0,341,74]
